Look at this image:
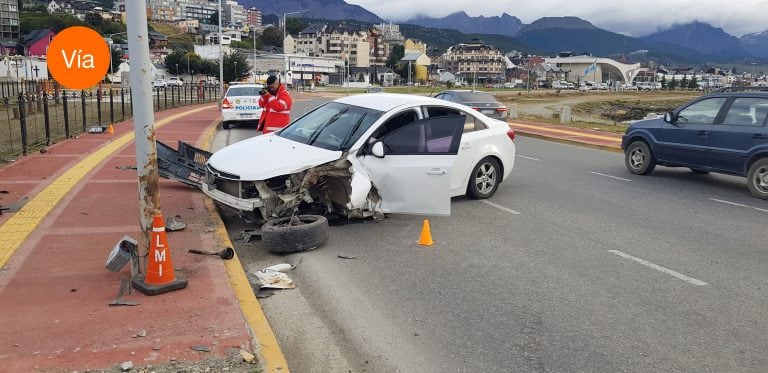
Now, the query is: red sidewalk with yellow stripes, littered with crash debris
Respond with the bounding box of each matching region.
[0,104,288,372]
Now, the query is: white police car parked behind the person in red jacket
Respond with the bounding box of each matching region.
[221,84,264,129]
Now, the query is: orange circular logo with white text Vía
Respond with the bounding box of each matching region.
[47,26,110,89]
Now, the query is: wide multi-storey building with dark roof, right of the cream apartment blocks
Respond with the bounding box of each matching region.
[441,38,507,81]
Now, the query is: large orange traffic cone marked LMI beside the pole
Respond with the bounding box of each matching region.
[133,214,187,295]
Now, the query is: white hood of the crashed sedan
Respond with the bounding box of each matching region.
[208,134,342,180]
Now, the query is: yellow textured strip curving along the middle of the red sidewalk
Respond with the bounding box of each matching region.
[0,106,212,268]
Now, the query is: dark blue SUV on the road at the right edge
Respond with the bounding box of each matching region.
[621,88,768,199]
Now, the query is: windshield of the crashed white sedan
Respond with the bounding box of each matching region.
[278,102,384,151]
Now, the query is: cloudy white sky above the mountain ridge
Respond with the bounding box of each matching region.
[346,0,768,37]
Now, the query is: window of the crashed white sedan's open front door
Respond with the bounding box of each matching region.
[381,115,465,155]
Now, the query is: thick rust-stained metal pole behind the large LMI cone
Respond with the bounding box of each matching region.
[125,0,160,256]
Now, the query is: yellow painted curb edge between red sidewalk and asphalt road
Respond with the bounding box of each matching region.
[200,121,290,373]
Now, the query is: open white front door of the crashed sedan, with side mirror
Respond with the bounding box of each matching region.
[361,115,466,215]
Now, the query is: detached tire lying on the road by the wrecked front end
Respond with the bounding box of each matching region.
[261,215,329,253]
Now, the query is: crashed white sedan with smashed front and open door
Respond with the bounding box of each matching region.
[201,93,515,220]
